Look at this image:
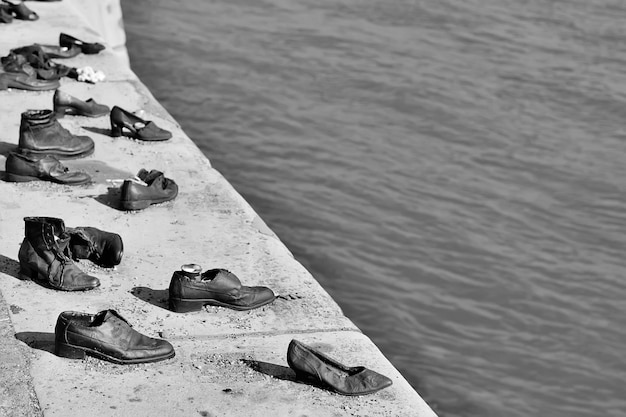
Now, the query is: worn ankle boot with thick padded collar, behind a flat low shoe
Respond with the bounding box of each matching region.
[18,110,94,159]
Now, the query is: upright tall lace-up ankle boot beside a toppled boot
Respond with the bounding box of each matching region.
[18,217,100,291]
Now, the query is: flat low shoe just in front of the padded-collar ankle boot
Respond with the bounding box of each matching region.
[6,152,91,185]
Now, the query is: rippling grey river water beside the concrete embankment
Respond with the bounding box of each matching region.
[123,0,626,417]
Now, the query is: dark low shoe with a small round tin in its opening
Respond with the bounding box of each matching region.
[169,265,276,313]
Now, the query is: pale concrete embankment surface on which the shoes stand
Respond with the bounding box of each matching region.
[0,0,435,417]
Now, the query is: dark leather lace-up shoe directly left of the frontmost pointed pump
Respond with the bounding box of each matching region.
[54,310,175,364]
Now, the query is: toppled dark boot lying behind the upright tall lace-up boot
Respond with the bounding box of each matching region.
[66,227,124,268]
